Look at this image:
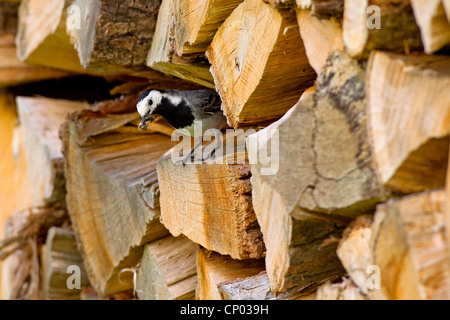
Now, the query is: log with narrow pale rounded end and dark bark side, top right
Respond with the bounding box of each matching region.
[343,0,423,58]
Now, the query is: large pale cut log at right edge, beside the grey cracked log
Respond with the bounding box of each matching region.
[367,52,450,193]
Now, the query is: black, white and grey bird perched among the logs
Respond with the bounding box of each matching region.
[136,89,227,163]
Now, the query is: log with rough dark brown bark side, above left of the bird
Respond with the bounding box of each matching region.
[68,0,161,75]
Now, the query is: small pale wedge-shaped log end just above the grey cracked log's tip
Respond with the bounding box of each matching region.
[297,10,344,74]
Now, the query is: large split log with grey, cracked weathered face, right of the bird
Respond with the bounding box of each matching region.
[247,51,388,292]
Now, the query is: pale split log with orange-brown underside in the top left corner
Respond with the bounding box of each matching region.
[16,0,84,72]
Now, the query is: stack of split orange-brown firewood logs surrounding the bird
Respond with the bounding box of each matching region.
[0,0,450,300]
